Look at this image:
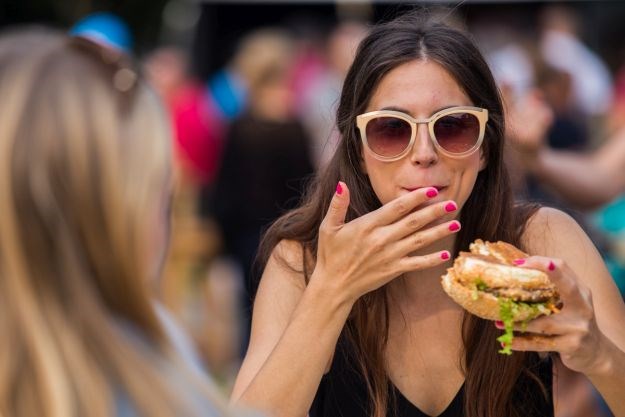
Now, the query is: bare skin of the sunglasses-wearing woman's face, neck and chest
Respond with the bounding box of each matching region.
[362,60,487,415]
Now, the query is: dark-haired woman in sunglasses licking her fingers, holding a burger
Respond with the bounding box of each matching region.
[233,15,625,417]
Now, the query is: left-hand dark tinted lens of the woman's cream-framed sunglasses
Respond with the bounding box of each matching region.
[367,117,412,157]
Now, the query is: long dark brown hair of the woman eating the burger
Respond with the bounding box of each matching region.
[258,13,544,417]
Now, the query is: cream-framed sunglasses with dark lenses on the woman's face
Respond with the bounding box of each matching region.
[356,107,488,162]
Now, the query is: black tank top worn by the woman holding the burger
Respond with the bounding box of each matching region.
[309,337,553,417]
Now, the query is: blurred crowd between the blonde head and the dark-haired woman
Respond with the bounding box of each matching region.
[144,15,367,384]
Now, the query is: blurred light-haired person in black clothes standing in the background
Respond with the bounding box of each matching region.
[211,28,314,351]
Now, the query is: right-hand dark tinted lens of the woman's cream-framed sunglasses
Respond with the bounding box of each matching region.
[434,113,480,153]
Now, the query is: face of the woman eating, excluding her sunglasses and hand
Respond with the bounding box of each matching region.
[362,60,483,219]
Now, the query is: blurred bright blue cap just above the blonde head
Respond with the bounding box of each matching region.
[69,12,132,53]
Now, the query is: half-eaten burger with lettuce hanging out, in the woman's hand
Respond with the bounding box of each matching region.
[441,239,561,354]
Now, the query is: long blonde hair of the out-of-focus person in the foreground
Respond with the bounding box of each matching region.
[0,30,235,417]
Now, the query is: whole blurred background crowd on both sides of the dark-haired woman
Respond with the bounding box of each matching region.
[1,5,625,417]
